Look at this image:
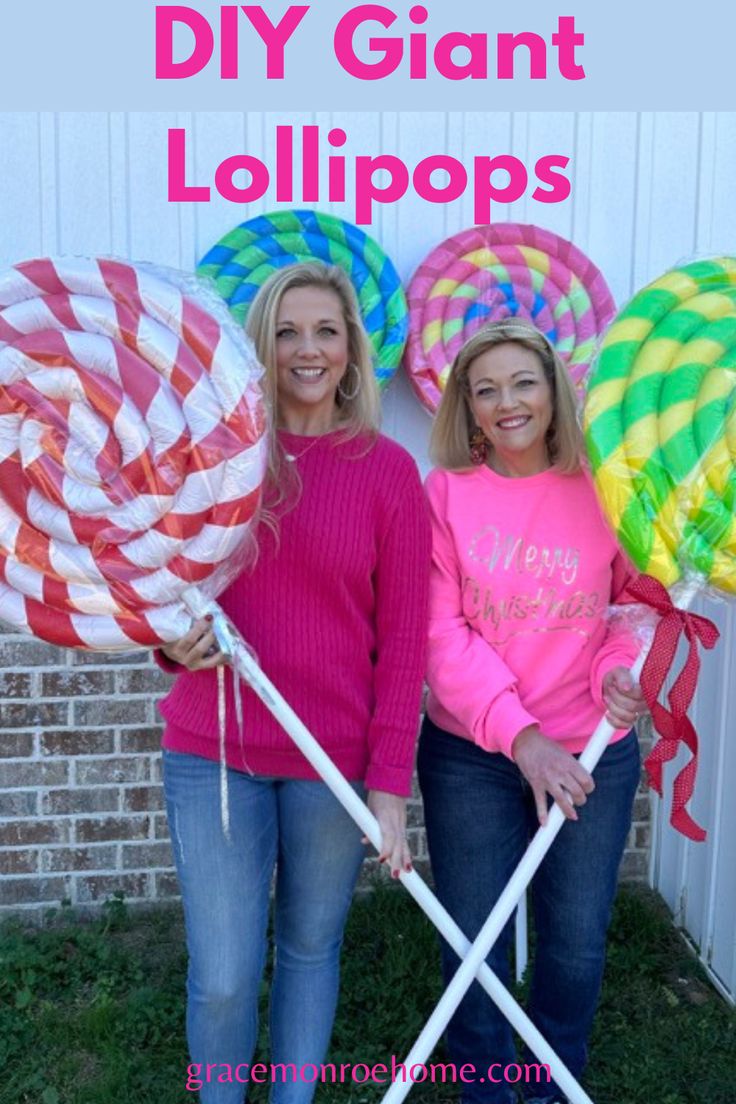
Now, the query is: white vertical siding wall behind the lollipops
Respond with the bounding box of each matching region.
[0,112,736,980]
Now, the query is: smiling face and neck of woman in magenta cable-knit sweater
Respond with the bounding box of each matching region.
[276,287,349,423]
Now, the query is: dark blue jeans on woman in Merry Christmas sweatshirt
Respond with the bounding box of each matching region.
[418,718,639,1104]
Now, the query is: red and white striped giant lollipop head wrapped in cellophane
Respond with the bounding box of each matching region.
[0,258,266,650]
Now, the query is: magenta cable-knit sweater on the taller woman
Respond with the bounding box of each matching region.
[160,432,430,795]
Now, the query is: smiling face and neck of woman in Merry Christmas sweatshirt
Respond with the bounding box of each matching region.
[468,341,554,476]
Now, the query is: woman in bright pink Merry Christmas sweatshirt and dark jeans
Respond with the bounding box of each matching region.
[419,319,643,1104]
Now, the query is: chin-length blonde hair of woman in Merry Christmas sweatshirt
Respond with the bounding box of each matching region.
[429,318,583,474]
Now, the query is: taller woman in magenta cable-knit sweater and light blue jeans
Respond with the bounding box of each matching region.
[156,264,430,1104]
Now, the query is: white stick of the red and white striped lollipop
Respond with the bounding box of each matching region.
[179,588,593,1104]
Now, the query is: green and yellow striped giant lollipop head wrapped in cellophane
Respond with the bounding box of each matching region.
[585,257,736,593]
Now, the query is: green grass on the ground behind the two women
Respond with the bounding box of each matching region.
[0,888,736,1104]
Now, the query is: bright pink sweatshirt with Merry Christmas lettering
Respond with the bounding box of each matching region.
[426,466,639,756]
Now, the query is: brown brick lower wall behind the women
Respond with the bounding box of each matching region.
[0,630,650,914]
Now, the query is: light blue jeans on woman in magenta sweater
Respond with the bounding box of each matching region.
[163,751,364,1104]
